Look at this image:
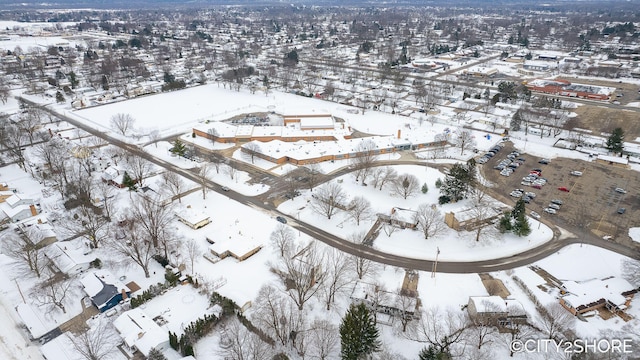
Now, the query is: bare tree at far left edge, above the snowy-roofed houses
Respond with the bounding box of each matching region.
[2,227,48,277]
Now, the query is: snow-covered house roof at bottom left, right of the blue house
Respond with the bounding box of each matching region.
[113,308,169,356]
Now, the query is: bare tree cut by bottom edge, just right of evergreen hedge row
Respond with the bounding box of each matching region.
[219,319,275,360]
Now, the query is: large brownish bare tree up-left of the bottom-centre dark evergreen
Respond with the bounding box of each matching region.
[273,240,324,310]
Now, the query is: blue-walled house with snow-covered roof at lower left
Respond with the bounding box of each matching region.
[80,270,131,312]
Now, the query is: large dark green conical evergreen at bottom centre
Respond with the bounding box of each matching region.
[340,303,380,360]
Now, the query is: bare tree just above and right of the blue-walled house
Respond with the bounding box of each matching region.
[109,219,154,278]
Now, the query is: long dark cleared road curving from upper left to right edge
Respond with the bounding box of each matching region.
[24,99,640,273]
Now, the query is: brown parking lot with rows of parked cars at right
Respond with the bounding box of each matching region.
[480,142,640,242]
